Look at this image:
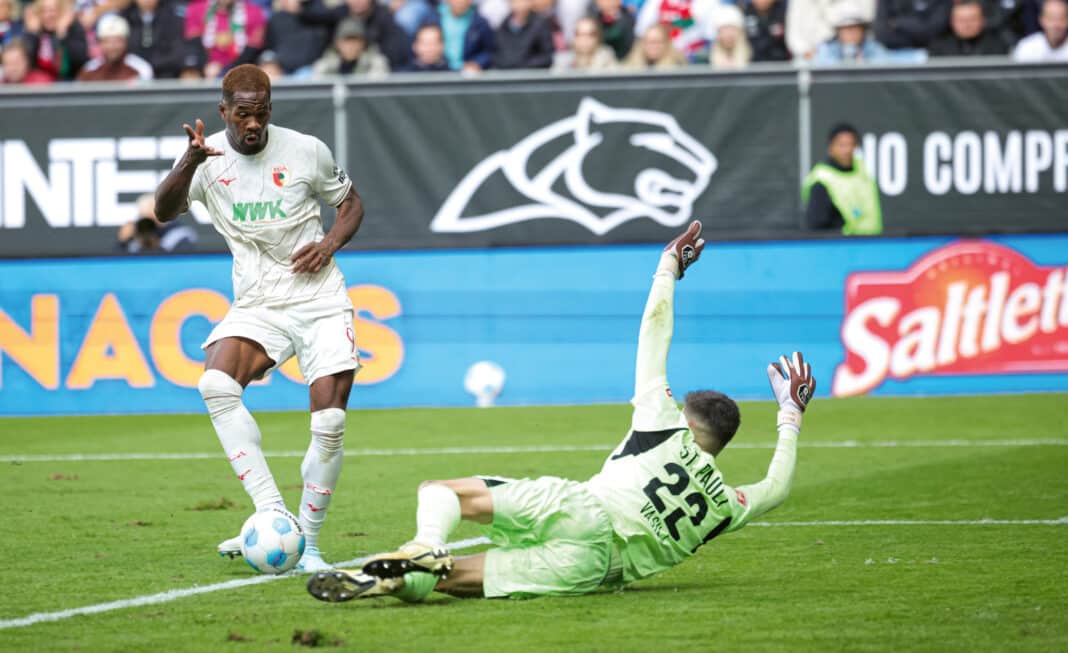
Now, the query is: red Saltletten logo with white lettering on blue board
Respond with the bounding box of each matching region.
[831,240,1068,397]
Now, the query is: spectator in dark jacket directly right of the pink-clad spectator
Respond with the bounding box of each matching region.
[235,0,330,76]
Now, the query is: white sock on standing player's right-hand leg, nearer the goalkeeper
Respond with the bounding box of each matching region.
[300,408,345,553]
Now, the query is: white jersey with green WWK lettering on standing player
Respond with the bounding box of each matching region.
[189,125,352,308]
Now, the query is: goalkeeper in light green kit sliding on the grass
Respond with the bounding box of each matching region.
[308,222,815,602]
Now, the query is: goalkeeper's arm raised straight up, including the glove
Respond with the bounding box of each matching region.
[631,221,705,431]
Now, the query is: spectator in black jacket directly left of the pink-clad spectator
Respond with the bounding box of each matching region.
[122,0,186,79]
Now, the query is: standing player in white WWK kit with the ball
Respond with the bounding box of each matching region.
[156,65,363,572]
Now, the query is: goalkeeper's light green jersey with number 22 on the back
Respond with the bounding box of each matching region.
[586,268,798,582]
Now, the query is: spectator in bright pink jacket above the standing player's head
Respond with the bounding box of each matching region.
[185,0,267,79]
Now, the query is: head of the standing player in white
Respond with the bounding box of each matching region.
[219,63,270,154]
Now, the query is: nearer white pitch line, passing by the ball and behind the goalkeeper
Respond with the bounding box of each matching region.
[0,516,1068,631]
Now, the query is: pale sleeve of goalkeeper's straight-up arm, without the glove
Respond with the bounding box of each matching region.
[631,259,685,431]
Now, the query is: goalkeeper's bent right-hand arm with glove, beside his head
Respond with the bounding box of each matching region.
[732,352,816,530]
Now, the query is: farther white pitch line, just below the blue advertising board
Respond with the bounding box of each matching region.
[0,438,1068,463]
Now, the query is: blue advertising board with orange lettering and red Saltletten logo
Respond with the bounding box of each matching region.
[0,235,1068,416]
